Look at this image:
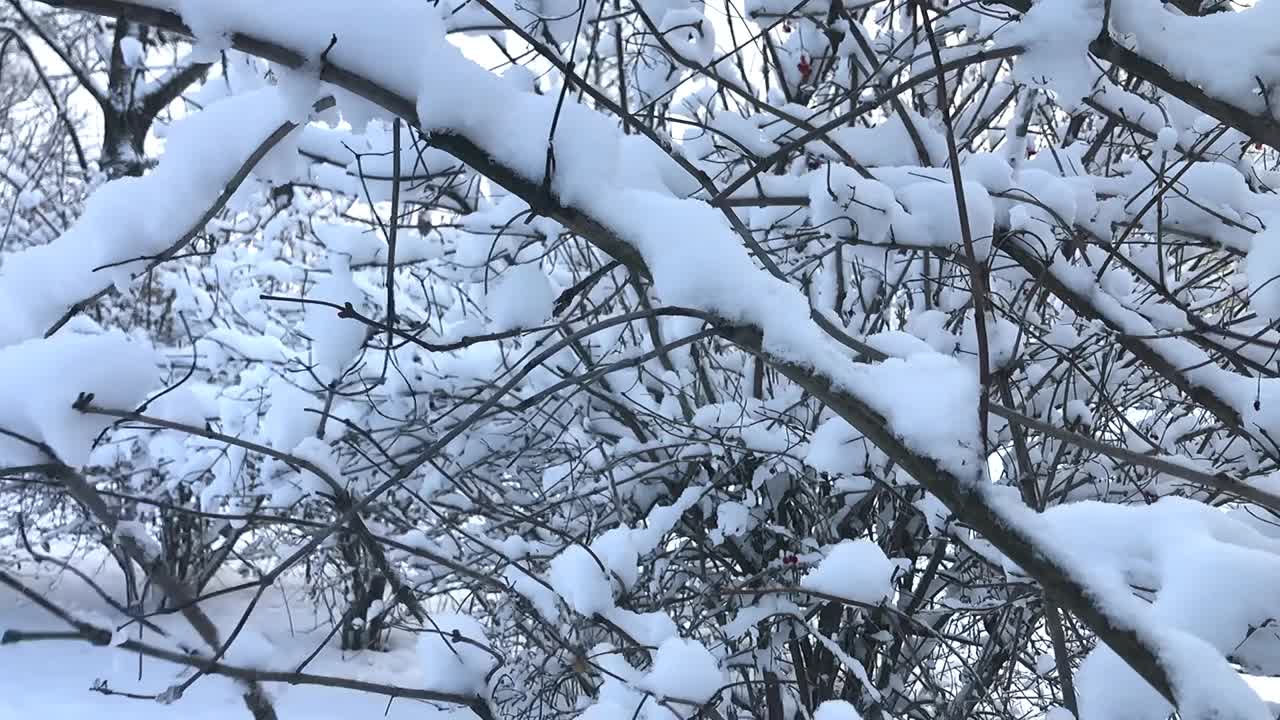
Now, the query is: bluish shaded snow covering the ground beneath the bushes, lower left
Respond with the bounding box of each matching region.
[0,565,475,720]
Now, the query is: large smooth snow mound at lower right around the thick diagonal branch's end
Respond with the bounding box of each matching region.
[993,497,1280,720]
